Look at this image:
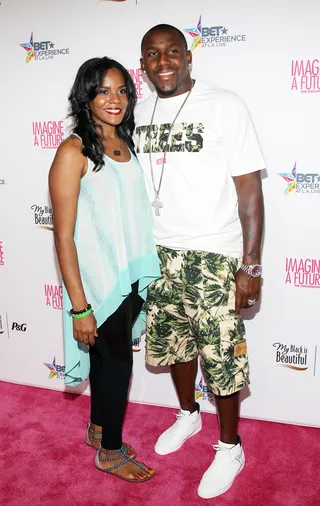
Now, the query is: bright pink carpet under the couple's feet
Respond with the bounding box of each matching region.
[0,382,320,506]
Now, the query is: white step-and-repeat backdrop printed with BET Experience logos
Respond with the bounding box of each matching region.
[0,0,320,426]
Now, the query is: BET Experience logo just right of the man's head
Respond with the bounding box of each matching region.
[184,16,246,51]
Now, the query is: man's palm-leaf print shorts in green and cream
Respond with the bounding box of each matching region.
[145,246,250,396]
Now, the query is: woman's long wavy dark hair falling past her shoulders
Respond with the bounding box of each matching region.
[69,56,137,172]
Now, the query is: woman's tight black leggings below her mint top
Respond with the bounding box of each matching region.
[90,282,143,450]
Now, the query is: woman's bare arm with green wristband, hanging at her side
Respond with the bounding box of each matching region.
[49,138,95,344]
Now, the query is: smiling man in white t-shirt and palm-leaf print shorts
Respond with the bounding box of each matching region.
[136,25,265,498]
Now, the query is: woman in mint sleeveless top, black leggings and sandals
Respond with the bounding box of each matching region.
[49,57,160,482]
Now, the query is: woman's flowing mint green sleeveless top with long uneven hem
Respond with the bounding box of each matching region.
[63,141,160,386]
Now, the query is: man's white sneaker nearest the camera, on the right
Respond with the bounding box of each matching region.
[198,438,245,499]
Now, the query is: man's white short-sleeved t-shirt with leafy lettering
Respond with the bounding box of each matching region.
[135,81,266,258]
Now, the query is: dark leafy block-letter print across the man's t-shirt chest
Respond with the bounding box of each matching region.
[136,122,204,153]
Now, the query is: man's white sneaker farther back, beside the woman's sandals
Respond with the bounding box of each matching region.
[154,405,202,455]
